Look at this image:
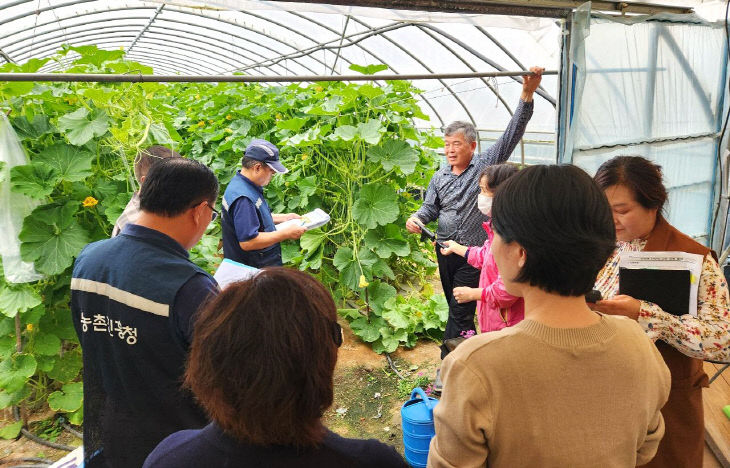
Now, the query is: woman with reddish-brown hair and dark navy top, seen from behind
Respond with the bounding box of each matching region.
[144,267,406,468]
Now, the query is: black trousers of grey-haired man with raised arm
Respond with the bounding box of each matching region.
[436,247,479,359]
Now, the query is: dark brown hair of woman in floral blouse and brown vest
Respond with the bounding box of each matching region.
[593,156,667,214]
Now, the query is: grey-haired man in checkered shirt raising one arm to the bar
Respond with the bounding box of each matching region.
[406,67,544,368]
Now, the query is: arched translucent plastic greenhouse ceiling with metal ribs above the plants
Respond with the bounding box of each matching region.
[0,0,719,141]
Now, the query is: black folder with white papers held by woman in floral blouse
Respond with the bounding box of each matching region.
[619,252,704,317]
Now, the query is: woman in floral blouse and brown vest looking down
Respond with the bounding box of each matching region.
[595,156,730,467]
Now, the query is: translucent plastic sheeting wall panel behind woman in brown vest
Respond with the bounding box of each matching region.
[561,5,727,244]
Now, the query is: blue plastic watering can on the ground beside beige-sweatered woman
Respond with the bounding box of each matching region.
[400,387,438,468]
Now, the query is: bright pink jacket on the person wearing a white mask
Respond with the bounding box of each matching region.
[466,222,525,333]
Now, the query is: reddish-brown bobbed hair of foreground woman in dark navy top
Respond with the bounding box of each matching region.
[185,267,341,447]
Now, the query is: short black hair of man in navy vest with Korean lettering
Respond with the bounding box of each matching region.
[139,158,218,217]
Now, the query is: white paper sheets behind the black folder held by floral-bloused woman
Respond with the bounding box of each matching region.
[618,252,704,317]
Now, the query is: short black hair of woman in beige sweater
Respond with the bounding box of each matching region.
[492,165,616,296]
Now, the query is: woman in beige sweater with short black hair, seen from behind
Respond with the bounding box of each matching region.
[428,166,670,468]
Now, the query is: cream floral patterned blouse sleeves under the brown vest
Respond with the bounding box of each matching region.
[596,239,730,362]
